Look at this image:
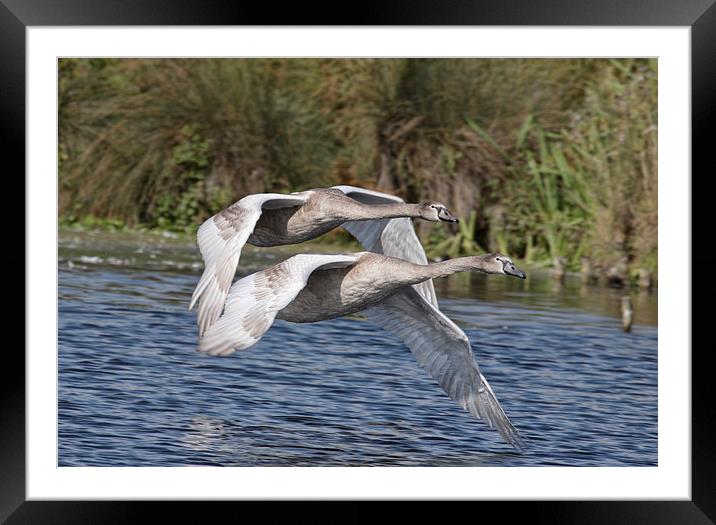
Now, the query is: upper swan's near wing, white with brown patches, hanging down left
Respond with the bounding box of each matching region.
[189,193,307,336]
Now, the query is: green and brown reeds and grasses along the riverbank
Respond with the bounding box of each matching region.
[59,59,657,281]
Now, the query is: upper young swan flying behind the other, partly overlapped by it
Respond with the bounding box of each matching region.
[189,185,458,335]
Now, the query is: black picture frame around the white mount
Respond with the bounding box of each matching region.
[0,0,716,524]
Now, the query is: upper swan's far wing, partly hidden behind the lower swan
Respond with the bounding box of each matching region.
[333,186,438,308]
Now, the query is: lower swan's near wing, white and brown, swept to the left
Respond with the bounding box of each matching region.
[199,254,358,355]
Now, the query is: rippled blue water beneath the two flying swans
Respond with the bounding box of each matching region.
[58,252,657,466]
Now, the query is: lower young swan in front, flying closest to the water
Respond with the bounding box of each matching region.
[198,252,526,449]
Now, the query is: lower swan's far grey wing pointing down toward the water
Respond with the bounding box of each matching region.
[363,288,523,448]
